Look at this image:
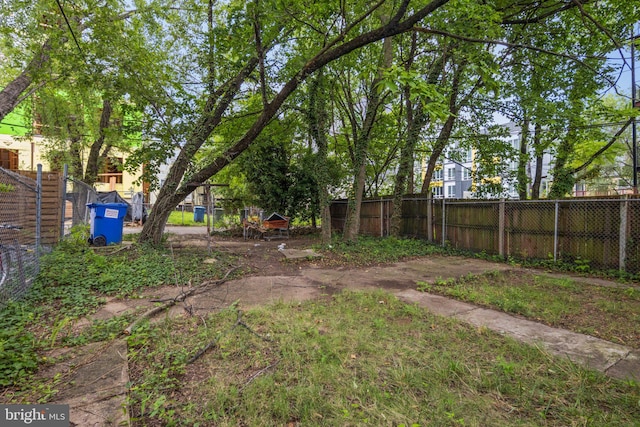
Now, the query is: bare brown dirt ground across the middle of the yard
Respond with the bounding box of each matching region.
[141,235,507,314]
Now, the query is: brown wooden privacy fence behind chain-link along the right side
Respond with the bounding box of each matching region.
[331,196,640,273]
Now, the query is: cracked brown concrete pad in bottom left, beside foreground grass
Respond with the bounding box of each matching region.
[52,339,130,427]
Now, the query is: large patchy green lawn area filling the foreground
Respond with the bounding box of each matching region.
[129,292,640,426]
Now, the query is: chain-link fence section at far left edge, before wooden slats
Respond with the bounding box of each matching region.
[0,168,44,308]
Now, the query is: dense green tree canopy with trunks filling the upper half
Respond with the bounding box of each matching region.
[0,0,639,243]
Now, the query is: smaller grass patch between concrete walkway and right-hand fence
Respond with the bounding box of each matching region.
[418,270,640,348]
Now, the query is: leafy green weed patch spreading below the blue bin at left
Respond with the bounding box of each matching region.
[0,234,238,392]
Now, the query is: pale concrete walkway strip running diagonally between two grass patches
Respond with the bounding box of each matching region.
[453,308,630,371]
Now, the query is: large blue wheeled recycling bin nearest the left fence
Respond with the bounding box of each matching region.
[87,203,129,246]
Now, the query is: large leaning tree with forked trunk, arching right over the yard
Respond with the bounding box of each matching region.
[140,0,448,243]
